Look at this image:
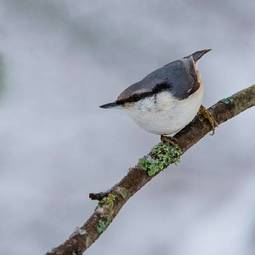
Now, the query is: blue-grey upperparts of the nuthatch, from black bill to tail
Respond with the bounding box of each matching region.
[100,49,210,108]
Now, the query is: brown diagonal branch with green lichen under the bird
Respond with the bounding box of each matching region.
[47,85,255,255]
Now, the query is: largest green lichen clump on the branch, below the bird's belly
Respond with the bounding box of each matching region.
[138,143,182,176]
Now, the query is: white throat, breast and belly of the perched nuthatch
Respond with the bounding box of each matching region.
[125,85,204,135]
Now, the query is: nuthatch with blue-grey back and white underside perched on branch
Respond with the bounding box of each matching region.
[100,49,217,143]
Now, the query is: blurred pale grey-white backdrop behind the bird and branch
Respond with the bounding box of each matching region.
[0,0,255,255]
